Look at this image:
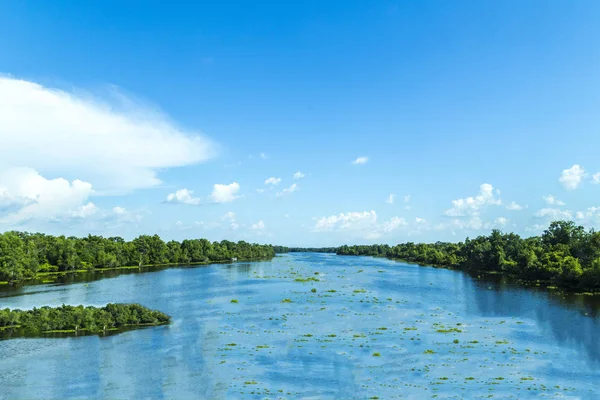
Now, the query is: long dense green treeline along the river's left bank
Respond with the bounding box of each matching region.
[0,231,275,283]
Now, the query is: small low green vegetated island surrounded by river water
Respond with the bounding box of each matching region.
[0,304,171,338]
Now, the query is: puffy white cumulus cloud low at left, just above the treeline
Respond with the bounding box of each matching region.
[0,167,97,224]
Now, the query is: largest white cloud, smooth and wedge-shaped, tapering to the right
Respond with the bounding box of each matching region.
[0,77,216,193]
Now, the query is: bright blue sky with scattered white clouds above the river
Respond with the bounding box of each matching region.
[0,0,600,246]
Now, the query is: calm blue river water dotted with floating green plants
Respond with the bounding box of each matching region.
[0,253,600,399]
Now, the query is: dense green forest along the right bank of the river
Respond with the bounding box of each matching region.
[337,221,600,290]
